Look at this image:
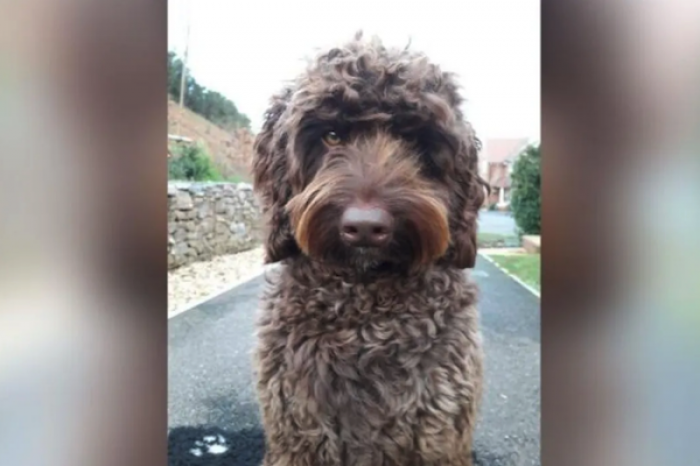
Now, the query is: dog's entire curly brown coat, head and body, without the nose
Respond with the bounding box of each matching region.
[254,35,485,466]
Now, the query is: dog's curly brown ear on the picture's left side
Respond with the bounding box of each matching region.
[253,89,299,263]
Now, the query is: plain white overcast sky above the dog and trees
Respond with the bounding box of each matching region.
[168,0,540,139]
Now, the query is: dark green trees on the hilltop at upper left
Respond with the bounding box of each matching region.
[168,52,250,130]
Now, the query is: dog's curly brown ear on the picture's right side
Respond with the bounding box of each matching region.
[446,129,489,269]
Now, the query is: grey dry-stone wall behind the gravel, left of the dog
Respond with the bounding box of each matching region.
[168,182,261,269]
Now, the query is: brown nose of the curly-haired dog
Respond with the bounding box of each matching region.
[340,207,393,247]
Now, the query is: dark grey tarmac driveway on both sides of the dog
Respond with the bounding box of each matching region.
[168,257,540,466]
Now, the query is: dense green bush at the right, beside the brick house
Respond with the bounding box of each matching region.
[510,145,542,235]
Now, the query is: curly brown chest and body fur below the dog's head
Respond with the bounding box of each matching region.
[256,265,481,465]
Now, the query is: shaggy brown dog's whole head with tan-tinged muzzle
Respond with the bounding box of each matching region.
[254,37,488,270]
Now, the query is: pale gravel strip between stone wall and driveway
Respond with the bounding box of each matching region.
[168,247,264,314]
